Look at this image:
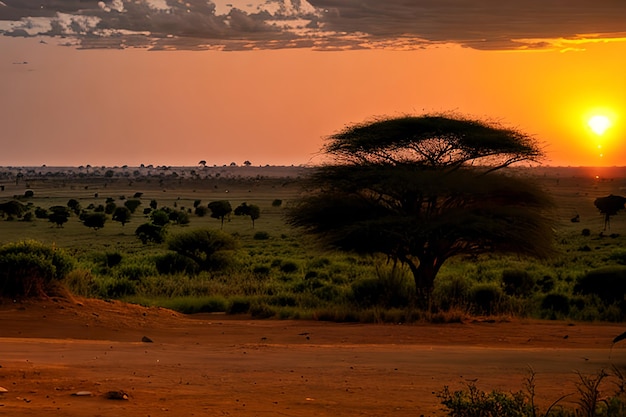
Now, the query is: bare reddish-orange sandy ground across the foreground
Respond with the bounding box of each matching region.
[0,300,626,417]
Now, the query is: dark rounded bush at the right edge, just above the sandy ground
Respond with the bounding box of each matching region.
[574,266,626,304]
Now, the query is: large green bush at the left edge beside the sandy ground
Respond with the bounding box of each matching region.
[0,241,74,297]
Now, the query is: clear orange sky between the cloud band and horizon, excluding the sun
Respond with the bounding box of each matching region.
[0,29,626,166]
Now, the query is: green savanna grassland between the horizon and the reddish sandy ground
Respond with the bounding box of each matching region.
[0,166,626,322]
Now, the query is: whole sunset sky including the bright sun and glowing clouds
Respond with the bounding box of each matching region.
[0,0,626,166]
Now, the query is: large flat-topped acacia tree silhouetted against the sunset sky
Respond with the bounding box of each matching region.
[287,115,553,296]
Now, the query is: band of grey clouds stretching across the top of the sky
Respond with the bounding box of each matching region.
[0,0,626,50]
